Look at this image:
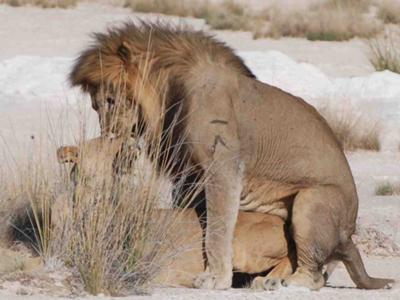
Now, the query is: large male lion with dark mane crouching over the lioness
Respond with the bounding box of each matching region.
[70,23,392,290]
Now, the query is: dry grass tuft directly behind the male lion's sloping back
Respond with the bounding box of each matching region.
[320,107,381,151]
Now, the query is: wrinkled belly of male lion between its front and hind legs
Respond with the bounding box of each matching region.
[239,179,299,219]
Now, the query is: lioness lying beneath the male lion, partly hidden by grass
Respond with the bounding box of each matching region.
[54,137,293,287]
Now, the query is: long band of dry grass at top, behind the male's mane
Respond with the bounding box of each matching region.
[126,0,382,41]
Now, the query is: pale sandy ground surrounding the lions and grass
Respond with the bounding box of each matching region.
[0,0,400,300]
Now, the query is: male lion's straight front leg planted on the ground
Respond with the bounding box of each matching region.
[194,161,242,289]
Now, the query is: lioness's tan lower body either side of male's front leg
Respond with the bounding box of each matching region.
[150,209,293,288]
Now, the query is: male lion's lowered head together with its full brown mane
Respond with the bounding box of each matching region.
[69,22,254,134]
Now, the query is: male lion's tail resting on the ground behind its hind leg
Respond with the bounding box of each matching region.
[338,238,394,290]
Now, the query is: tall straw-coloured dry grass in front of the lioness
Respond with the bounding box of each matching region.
[0,73,201,295]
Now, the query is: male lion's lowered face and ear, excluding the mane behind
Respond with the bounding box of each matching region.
[70,34,147,134]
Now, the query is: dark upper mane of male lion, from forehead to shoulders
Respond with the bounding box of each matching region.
[69,21,255,88]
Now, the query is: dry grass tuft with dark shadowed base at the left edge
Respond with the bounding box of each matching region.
[0,138,59,260]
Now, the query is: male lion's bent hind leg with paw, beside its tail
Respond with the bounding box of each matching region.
[282,186,348,290]
